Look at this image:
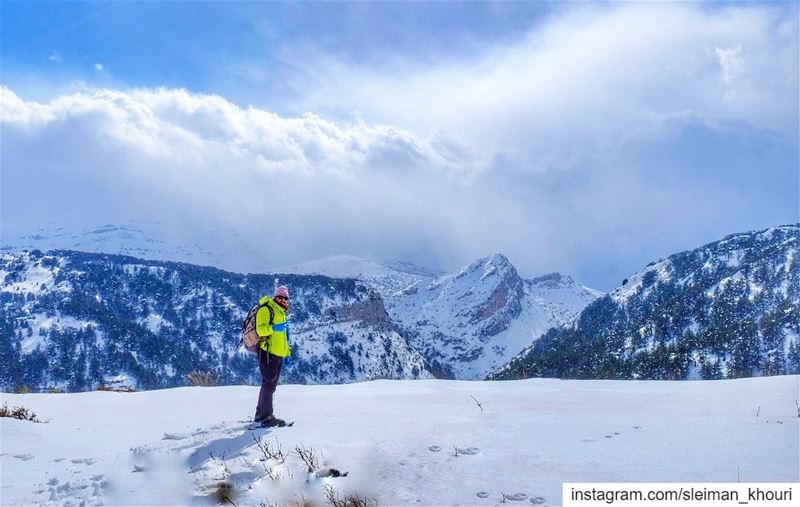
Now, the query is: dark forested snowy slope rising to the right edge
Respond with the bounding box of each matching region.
[493,225,800,379]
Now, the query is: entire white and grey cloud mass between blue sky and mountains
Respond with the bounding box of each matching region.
[0,4,800,289]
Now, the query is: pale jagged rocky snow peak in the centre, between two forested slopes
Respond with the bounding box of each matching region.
[385,254,598,379]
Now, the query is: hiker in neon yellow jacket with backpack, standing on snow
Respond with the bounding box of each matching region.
[253,285,292,426]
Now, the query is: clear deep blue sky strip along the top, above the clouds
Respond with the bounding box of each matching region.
[0,2,552,114]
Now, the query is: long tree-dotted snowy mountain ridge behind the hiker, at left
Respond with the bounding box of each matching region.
[0,251,431,390]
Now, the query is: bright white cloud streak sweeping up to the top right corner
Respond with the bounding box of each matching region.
[282,4,798,163]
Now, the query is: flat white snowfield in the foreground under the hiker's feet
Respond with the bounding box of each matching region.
[0,376,800,506]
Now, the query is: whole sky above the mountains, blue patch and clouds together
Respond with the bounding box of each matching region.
[0,2,800,290]
